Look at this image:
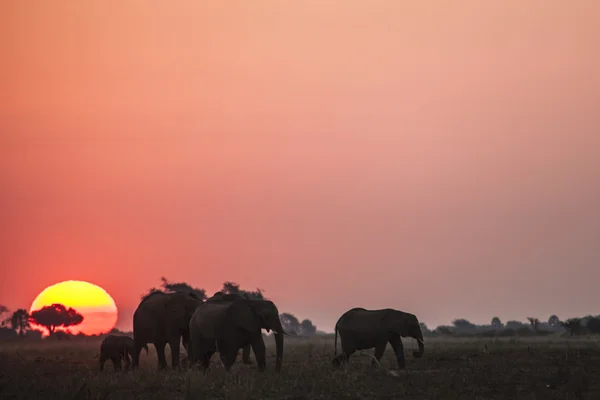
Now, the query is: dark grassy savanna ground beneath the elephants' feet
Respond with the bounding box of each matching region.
[0,337,600,400]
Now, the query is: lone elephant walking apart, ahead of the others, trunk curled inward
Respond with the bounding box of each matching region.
[332,308,425,369]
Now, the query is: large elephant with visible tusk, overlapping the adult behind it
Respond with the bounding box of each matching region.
[188,294,286,373]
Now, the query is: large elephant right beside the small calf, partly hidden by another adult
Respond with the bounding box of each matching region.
[131,292,202,369]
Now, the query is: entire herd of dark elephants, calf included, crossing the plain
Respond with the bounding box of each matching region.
[100,292,425,371]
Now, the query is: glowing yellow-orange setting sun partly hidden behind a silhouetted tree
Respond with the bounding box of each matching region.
[29,281,117,335]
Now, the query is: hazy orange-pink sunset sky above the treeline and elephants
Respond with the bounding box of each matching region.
[0,0,600,331]
